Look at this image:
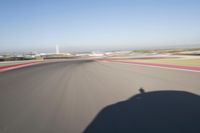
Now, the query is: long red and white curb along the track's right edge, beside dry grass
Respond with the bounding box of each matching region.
[107,60,200,71]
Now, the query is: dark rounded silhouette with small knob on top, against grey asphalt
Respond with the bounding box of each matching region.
[84,89,200,133]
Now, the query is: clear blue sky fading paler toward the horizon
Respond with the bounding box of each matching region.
[0,0,200,51]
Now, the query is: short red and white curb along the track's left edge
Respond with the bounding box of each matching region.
[0,61,42,72]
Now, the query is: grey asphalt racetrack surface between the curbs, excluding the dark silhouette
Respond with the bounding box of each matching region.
[0,60,200,133]
